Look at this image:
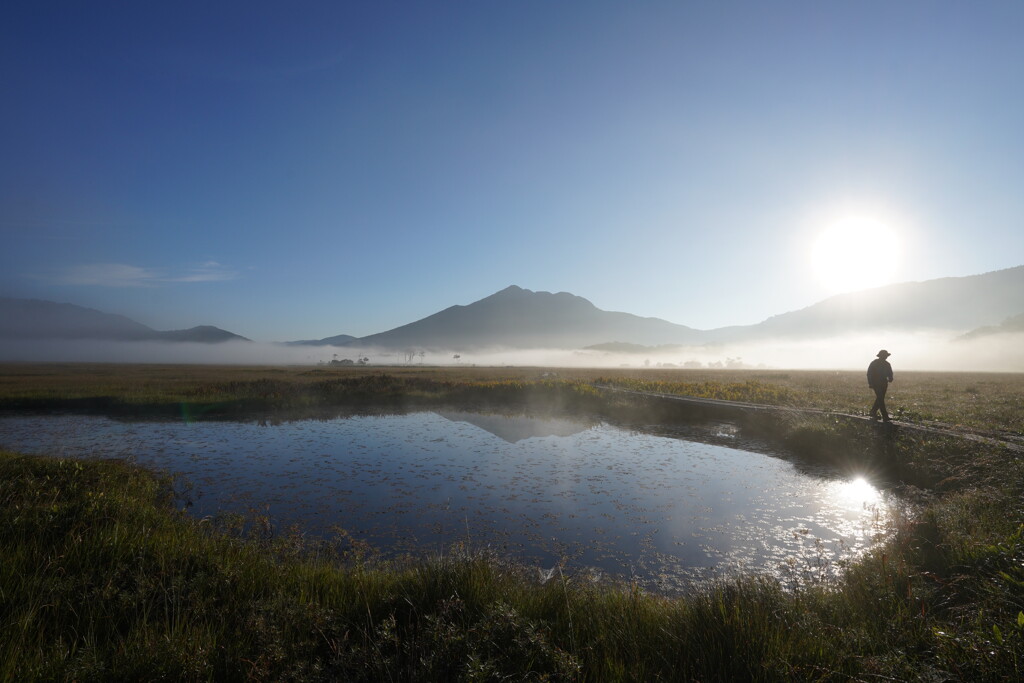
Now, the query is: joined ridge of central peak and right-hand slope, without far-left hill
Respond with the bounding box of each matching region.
[314,266,1024,350]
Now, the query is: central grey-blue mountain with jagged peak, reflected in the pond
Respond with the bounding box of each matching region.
[349,285,702,350]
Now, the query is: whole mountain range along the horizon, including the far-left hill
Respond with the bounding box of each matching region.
[0,265,1024,352]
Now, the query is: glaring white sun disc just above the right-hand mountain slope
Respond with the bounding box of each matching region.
[811,216,900,294]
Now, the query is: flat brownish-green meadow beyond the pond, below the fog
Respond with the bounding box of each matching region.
[0,364,1024,436]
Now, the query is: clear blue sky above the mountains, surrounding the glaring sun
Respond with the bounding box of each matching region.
[0,1,1024,340]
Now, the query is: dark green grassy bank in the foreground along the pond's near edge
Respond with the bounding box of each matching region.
[0,440,1024,681]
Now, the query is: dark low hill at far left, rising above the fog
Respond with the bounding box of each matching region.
[0,298,249,343]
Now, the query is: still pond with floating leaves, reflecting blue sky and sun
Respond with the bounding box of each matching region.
[0,412,894,592]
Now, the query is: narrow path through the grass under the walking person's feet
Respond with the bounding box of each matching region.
[594,384,1024,453]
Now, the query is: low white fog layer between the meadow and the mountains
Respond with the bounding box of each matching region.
[0,332,1024,372]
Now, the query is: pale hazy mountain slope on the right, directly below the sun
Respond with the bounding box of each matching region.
[708,265,1024,342]
